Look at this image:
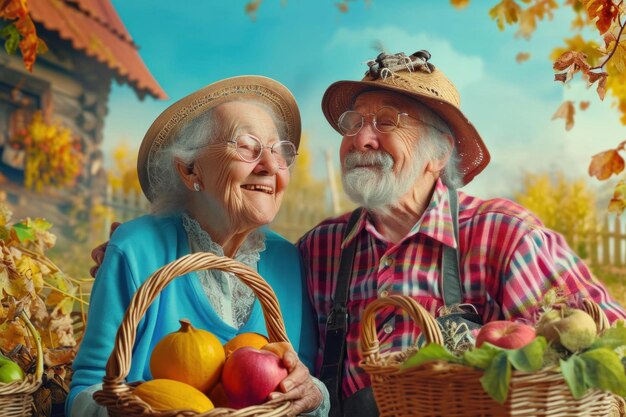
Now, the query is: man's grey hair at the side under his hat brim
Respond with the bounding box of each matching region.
[413,100,463,189]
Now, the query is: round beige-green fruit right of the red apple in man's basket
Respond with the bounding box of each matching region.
[536,307,598,353]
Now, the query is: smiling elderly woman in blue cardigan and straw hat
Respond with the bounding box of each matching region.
[66,76,328,417]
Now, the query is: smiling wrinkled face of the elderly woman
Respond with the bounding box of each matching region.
[195,101,289,226]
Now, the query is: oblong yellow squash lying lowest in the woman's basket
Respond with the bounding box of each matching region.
[133,379,214,413]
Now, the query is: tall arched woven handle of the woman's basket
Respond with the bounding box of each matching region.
[102,252,289,392]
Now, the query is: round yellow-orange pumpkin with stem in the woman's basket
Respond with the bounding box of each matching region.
[150,319,225,392]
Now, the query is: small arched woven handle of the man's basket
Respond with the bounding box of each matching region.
[359,295,443,363]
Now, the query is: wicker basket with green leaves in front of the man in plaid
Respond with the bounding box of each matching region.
[360,295,626,417]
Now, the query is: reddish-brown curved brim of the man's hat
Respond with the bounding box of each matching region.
[322,81,491,184]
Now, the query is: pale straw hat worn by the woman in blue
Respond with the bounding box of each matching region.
[137,75,301,201]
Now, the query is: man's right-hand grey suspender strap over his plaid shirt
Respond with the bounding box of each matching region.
[441,188,463,307]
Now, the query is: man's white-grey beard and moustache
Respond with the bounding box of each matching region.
[341,151,422,210]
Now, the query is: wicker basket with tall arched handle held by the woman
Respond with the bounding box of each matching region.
[94,252,291,417]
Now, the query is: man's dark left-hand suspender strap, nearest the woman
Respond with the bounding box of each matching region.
[320,209,362,417]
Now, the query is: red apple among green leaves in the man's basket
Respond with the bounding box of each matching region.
[476,320,535,349]
